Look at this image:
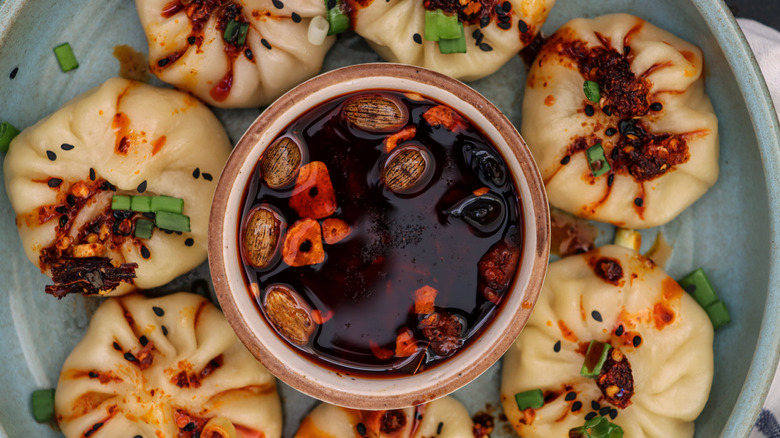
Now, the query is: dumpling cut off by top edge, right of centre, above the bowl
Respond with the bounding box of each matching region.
[347,0,555,81]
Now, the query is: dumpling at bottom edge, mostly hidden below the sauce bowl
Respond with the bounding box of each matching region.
[295,397,472,438]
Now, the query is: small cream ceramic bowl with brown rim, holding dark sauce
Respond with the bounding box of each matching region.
[209,63,550,409]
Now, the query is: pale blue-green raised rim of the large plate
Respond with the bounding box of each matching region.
[0,0,780,437]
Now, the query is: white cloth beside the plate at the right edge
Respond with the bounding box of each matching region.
[737,18,780,438]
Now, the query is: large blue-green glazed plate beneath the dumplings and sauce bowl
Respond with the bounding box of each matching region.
[0,0,780,438]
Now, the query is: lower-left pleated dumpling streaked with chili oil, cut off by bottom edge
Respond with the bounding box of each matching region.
[55,293,282,438]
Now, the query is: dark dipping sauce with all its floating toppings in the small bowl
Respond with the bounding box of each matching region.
[238,90,523,376]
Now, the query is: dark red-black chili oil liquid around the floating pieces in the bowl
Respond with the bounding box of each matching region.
[237,90,524,377]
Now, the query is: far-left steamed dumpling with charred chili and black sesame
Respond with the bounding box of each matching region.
[3,79,231,296]
